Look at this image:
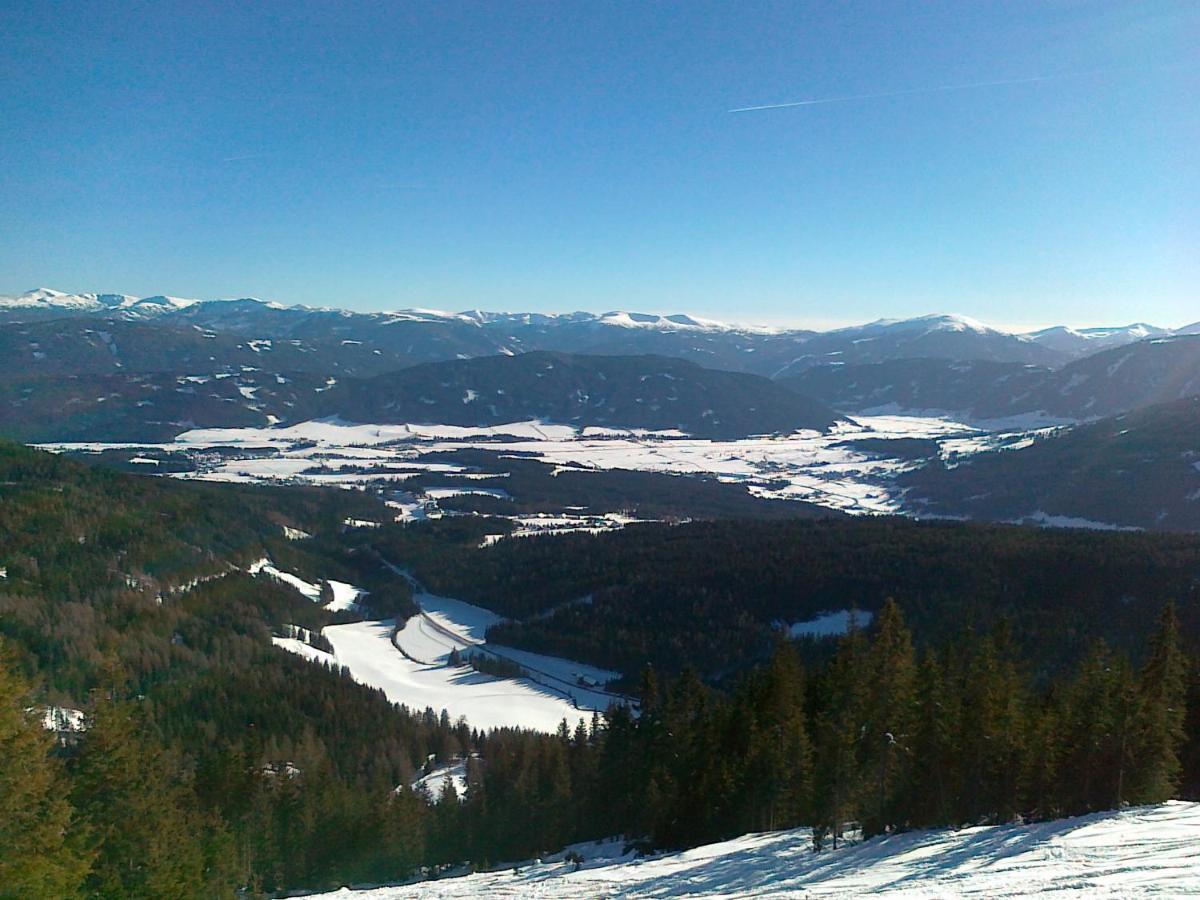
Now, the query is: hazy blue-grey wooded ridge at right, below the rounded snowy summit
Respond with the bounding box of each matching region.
[780,335,1200,420]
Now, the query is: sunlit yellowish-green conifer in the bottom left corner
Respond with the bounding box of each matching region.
[0,643,89,899]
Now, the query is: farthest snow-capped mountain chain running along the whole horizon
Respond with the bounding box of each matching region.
[0,288,1185,377]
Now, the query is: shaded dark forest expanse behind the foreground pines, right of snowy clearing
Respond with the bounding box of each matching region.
[373,518,1200,676]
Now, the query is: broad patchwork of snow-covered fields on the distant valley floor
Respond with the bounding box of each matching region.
[42,415,1030,512]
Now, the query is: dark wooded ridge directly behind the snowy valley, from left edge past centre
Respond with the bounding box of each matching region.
[0,352,836,442]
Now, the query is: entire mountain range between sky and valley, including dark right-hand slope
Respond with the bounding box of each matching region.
[7,289,1200,529]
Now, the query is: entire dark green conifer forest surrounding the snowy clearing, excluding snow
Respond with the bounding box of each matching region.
[0,444,1200,898]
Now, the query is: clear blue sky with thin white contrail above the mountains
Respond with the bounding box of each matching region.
[0,0,1200,325]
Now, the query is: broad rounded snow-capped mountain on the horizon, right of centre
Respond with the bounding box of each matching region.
[776,314,1068,378]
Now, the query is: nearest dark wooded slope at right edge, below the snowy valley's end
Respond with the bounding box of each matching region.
[901,397,1200,530]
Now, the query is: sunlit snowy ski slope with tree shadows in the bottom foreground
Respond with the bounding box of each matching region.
[302,802,1200,900]
